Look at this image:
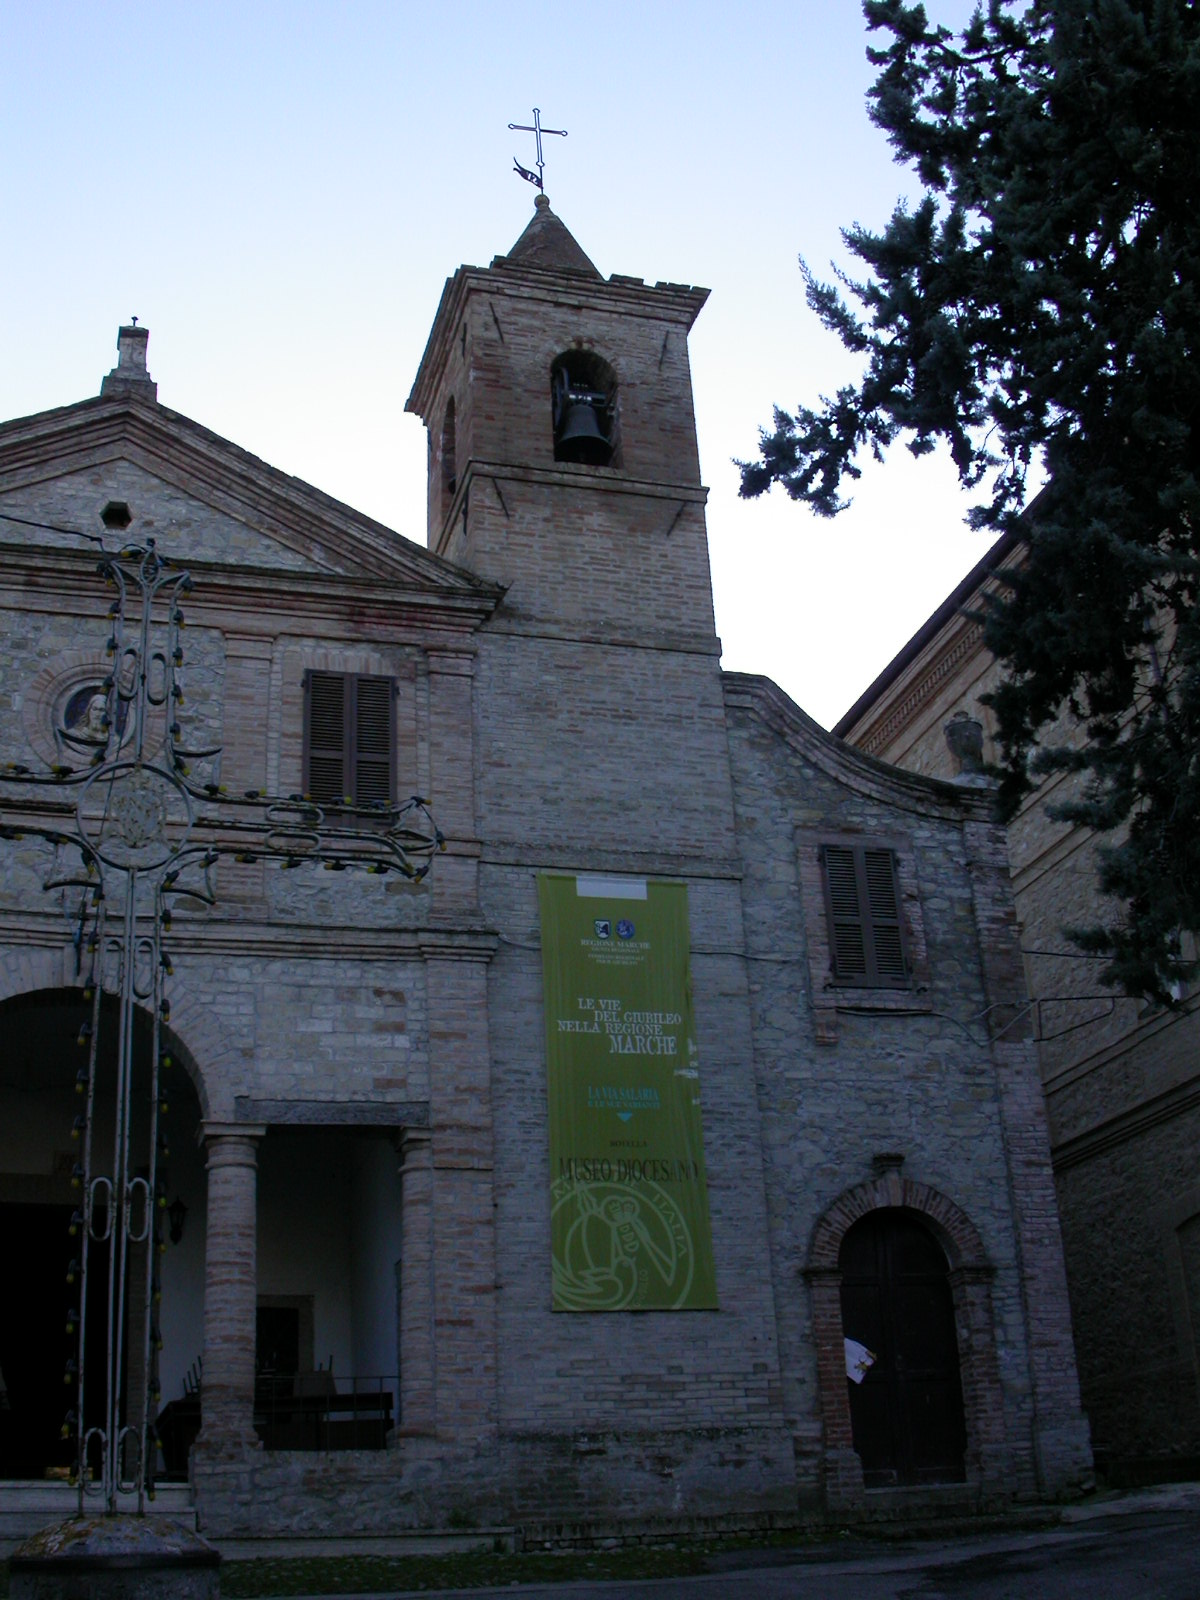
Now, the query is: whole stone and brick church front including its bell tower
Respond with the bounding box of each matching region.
[0,197,1091,1538]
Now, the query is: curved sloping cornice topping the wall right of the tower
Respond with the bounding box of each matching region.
[722,672,994,822]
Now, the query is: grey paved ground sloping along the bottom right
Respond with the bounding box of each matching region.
[296,1485,1200,1600]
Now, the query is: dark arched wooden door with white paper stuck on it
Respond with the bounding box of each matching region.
[838,1208,966,1488]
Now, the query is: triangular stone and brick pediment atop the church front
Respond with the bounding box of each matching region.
[0,397,498,602]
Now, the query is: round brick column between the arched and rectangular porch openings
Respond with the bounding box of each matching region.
[195,1123,266,1454]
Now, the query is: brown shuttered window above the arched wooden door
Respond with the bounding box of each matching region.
[821,845,909,989]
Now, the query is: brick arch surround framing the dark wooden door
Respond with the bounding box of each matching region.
[805,1170,1008,1510]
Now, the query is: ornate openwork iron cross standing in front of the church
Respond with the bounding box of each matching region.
[0,534,443,1512]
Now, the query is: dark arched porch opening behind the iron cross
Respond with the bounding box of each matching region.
[0,987,205,1480]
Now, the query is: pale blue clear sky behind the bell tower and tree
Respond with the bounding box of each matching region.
[0,0,986,723]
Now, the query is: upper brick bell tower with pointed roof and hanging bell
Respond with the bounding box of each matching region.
[408,194,717,653]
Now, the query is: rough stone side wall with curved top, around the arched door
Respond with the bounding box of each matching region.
[726,677,1090,1501]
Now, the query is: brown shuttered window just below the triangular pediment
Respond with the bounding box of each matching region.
[304,672,395,805]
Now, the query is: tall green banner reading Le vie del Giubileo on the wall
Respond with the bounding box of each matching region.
[538,875,717,1310]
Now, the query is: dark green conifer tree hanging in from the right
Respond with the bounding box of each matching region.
[741,0,1200,998]
